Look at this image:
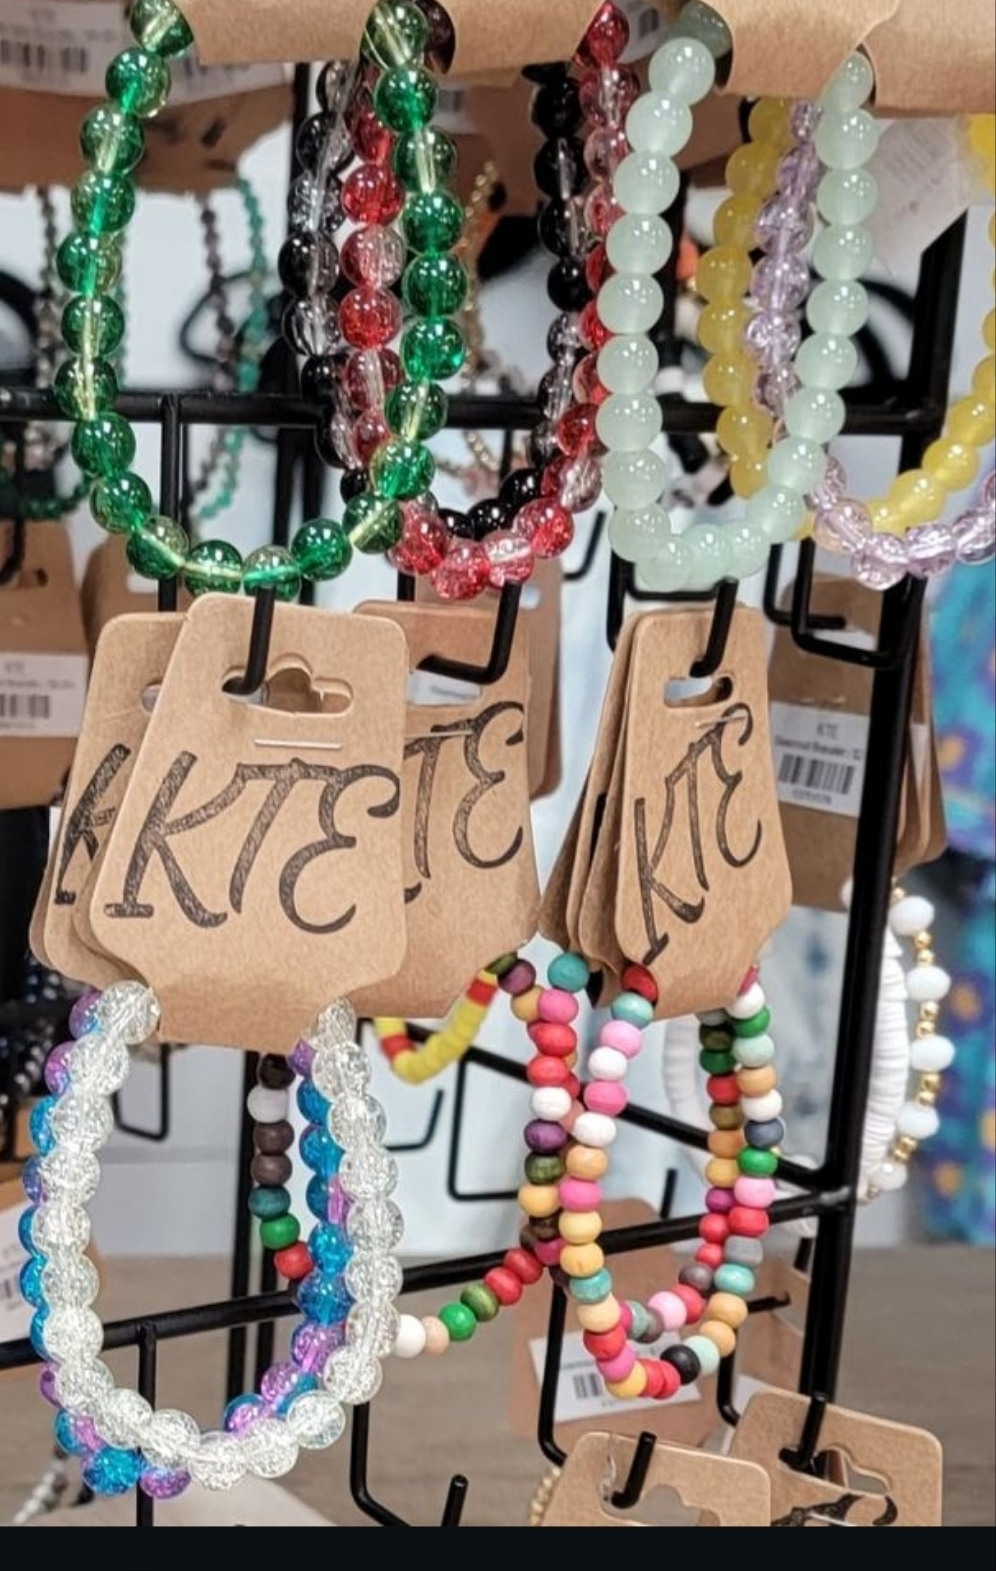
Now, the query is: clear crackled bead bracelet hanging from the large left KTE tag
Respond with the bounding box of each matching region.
[20,982,401,1497]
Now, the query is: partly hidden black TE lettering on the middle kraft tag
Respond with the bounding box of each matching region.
[405,701,525,905]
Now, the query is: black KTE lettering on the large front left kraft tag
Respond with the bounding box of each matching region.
[104,753,401,933]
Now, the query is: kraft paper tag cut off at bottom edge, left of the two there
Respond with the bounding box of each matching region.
[540,1431,771,1527]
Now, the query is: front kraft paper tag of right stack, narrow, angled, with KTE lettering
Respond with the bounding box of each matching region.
[614,606,782,1018]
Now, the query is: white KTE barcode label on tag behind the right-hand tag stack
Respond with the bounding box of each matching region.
[771,704,869,818]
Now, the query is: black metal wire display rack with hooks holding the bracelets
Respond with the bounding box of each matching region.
[0,58,965,1527]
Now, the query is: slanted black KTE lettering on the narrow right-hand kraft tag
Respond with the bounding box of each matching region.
[633,704,762,966]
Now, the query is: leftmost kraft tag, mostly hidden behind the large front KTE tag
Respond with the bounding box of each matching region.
[31,611,184,988]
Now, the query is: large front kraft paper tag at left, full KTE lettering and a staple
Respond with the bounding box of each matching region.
[91,595,407,1053]
